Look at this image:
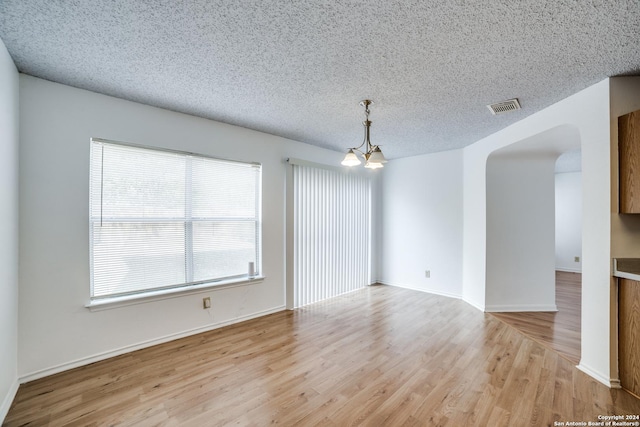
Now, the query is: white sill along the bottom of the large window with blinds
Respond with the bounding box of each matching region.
[85,276,265,311]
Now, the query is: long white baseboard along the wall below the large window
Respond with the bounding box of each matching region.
[19,305,286,384]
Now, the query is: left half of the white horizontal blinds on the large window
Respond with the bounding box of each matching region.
[91,143,185,297]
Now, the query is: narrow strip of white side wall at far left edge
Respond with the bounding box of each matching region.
[0,40,19,423]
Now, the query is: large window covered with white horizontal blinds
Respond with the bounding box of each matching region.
[90,139,261,300]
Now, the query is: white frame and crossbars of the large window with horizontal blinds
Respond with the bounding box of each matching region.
[85,138,264,310]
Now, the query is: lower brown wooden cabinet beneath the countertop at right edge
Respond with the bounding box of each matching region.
[618,279,640,396]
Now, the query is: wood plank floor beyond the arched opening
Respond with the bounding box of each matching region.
[491,271,582,365]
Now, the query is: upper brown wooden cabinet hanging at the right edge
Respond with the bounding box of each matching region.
[618,110,640,213]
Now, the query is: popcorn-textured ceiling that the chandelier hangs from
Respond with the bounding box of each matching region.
[0,0,640,165]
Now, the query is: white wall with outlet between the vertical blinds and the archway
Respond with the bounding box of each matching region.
[378,150,463,298]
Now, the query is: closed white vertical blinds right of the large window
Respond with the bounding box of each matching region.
[293,165,371,307]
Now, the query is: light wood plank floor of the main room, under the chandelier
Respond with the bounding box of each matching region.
[5,286,640,426]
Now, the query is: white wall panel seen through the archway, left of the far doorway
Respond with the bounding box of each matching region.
[485,150,557,312]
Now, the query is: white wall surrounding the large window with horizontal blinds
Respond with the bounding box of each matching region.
[18,75,350,381]
